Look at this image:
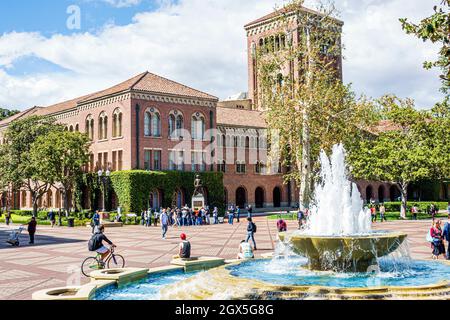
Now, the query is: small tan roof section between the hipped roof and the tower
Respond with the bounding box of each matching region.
[216,107,267,128]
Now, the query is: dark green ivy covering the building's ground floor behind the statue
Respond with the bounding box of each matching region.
[111,170,225,213]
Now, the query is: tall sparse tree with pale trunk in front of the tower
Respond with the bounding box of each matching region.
[255,1,373,208]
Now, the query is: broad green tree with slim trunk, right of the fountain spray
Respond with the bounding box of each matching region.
[347,96,450,218]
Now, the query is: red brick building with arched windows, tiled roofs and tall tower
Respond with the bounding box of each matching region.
[0,5,448,209]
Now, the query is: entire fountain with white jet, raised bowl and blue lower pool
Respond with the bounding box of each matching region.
[36,145,450,300]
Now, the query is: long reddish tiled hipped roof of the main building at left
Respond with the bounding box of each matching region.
[0,71,219,126]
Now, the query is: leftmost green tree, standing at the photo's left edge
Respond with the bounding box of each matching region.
[0,116,63,215]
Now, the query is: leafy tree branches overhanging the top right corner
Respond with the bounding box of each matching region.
[400,0,450,93]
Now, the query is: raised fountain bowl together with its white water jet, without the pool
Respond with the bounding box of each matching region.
[279,145,407,272]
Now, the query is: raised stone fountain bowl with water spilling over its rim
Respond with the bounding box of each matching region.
[279,232,407,272]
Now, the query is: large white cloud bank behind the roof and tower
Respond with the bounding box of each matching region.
[0,0,440,108]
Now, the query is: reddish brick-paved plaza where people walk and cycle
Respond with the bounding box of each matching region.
[0,217,442,300]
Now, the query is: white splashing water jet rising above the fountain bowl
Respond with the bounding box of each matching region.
[301,144,372,236]
